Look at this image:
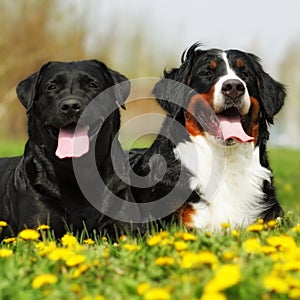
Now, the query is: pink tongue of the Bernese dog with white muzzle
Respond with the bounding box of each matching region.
[217,114,254,143]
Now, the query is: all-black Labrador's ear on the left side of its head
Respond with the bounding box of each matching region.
[16,72,39,112]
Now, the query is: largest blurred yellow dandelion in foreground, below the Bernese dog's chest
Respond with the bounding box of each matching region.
[204,265,242,293]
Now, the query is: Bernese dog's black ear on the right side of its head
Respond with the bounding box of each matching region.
[252,55,286,124]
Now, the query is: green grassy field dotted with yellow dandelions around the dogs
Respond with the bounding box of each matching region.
[0,144,300,300]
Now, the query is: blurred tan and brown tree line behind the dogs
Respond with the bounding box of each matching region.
[0,0,300,147]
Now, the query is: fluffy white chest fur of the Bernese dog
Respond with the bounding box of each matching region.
[174,136,271,230]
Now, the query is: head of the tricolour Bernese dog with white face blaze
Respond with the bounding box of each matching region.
[154,43,286,145]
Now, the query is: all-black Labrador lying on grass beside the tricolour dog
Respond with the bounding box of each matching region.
[0,60,138,238]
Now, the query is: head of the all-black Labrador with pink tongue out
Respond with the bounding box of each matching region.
[17,60,130,158]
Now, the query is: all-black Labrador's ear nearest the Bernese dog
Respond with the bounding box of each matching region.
[92,59,130,109]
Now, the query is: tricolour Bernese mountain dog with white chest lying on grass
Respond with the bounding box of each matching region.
[130,43,286,230]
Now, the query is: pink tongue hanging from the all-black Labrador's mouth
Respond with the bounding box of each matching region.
[55,126,90,159]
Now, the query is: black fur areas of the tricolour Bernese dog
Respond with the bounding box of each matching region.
[130,43,286,227]
